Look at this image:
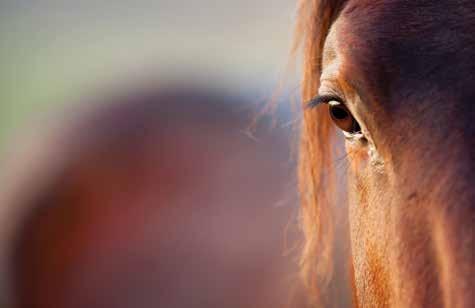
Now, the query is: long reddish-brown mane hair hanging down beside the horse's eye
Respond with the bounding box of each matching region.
[293,0,347,307]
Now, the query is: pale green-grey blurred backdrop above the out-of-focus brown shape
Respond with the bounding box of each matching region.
[0,0,295,148]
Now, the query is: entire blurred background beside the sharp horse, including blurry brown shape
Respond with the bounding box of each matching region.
[0,0,305,308]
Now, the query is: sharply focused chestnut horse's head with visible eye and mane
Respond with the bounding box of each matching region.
[295,0,475,307]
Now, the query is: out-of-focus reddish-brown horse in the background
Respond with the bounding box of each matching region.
[0,82,304,308]
